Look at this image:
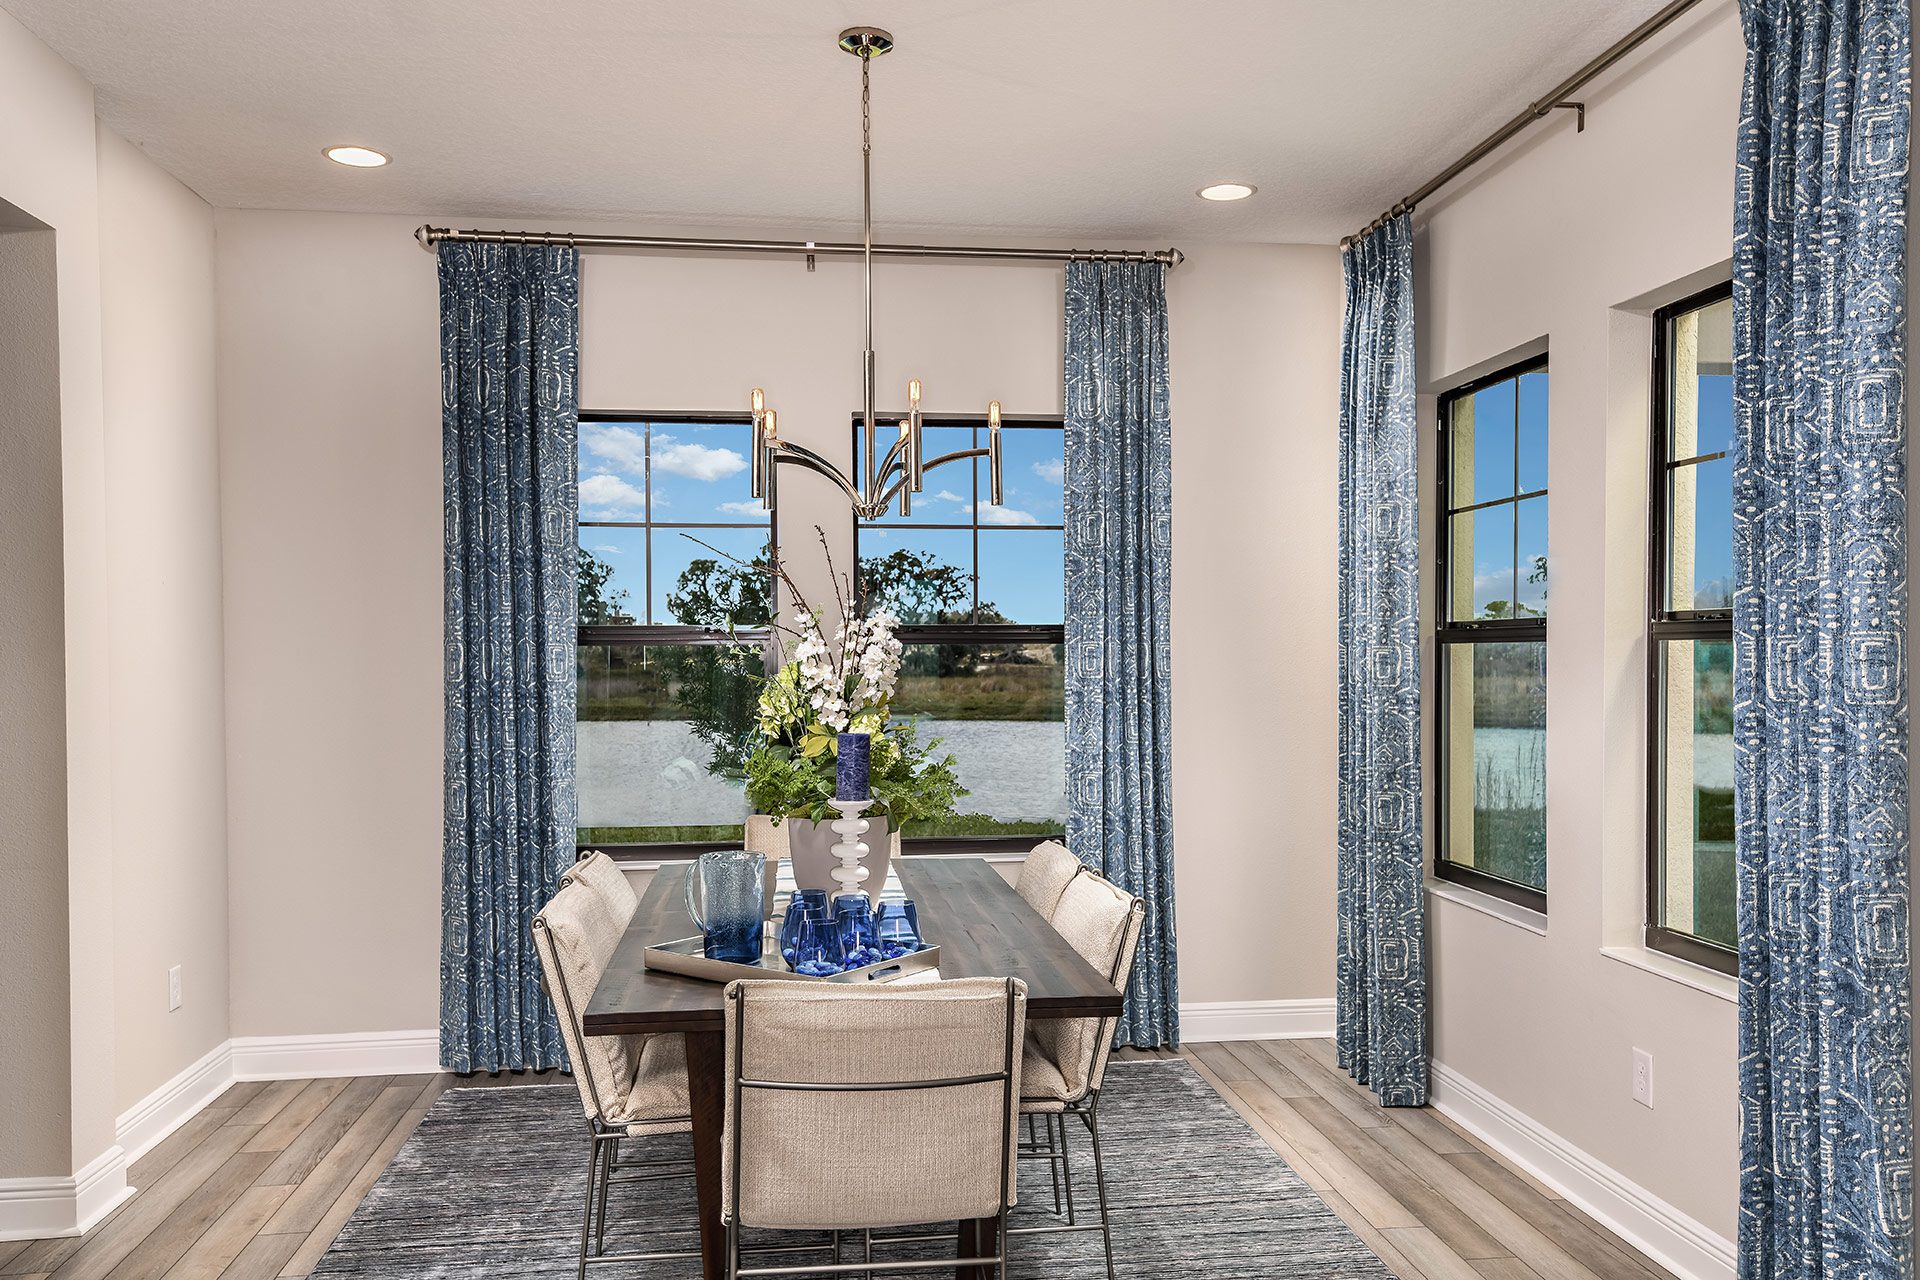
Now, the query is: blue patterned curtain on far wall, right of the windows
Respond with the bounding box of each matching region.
[1064,263,1181,1048]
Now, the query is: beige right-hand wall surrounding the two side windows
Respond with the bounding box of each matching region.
[1415,0,1741,1238]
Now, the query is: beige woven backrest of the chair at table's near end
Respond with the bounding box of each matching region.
[720,979,1027,1228]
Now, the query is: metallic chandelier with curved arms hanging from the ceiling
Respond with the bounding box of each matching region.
[753,27,1000,520]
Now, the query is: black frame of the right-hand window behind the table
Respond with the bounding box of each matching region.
[847,413,1068,858]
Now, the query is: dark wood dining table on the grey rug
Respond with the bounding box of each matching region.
[582,854,1121,1280]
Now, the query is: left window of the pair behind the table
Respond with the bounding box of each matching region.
[576,415,774,854]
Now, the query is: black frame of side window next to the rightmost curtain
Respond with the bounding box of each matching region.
[1642,280,1740,975]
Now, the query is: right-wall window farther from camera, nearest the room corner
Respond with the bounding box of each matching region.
[1434,359,1548,912]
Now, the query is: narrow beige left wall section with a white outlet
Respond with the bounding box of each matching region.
[98,129,228,1111]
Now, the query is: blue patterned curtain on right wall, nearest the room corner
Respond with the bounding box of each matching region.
[1334,213,1427,1107]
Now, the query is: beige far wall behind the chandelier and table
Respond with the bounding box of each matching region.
[217,211,1340,1034]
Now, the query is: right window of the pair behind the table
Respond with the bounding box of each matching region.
[854,418,1068,850]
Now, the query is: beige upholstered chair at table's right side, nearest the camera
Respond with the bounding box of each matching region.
[1014,864,1146,1280]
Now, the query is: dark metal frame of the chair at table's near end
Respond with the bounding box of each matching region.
[726,979,1021,1280]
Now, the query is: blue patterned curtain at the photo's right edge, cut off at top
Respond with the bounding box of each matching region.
[1734,0,1912,1280]
